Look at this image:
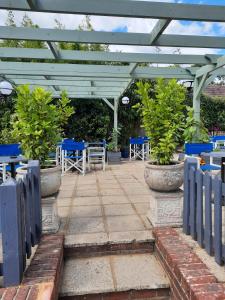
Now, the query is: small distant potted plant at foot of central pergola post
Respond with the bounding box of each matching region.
[107,128,121,164]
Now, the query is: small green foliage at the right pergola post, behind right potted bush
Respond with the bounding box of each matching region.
[184,107,209,143]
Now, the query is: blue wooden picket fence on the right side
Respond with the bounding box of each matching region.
[183,158,225,265]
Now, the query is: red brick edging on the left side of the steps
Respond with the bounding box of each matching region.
[0,234,64,300]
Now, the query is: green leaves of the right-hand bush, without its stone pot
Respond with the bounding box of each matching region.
[135,79,185,165]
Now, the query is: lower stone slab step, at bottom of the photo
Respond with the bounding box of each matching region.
[60,253,170,300]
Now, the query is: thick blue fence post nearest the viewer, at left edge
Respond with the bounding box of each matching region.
[0,179,24,286]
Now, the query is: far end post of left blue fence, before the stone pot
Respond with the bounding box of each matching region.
[28,160,42,244]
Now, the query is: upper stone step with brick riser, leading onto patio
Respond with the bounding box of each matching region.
[64,230,154,257]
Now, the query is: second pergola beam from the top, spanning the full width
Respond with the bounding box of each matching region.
[0,26,225,49]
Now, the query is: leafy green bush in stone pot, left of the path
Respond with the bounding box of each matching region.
[13,85,74,197]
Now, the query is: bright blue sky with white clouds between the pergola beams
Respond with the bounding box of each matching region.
[0,0,225,55]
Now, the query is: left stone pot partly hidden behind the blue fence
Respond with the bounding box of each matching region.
[17,166,61,198]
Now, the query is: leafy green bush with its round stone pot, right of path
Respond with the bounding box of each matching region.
[136,79,185,192]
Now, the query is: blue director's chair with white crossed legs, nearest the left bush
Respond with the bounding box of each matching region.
[61,141,86,175]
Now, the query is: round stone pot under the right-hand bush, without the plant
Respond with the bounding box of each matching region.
[144,162,184,192]
